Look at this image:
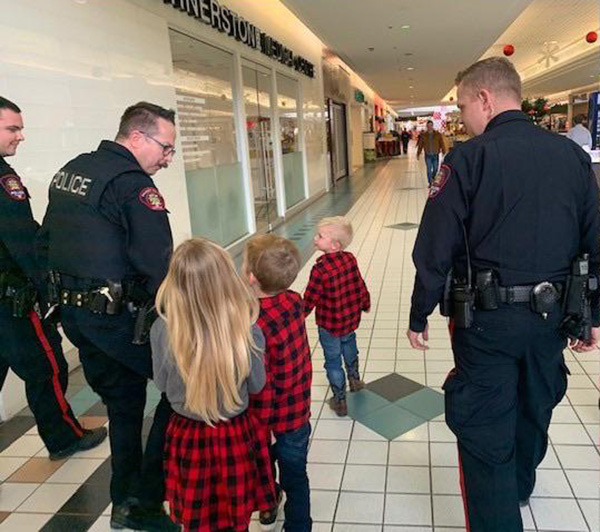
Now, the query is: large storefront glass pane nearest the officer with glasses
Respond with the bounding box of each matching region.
[170,30,248,246]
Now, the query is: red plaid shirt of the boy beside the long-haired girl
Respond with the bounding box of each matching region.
[250,290,312,434]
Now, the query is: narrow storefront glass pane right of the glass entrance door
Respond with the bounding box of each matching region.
[277,73,305,209]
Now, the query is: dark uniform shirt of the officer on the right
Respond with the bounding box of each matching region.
[410,110,600,332]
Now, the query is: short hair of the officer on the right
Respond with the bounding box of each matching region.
[455,57,521,103]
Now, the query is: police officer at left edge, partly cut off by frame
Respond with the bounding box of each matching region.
[0,97,106,460]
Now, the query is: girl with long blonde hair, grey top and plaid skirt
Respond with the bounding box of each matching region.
[150,239,275,532]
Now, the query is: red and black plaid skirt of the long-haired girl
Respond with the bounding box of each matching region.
[165,412,276,532]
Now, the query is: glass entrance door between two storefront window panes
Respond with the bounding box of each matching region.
[242,60,278,231]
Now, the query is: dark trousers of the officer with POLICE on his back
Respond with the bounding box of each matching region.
[61,307,171,508]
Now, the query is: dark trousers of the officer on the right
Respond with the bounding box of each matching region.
[444,304,568,532]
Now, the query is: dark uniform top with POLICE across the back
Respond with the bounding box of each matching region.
[40,140,173,294]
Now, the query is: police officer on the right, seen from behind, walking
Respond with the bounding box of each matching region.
[407,57,600,532]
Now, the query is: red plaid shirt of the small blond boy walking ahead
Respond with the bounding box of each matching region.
[304,251,371,336]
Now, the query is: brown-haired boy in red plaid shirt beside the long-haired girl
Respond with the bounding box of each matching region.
[244,235,312,532]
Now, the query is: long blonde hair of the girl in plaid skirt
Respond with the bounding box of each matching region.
[156,238,258,425]
